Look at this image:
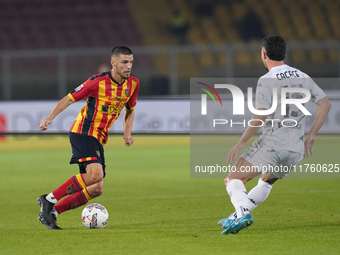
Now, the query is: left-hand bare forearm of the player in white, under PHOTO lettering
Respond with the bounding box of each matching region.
[225,111,268,163]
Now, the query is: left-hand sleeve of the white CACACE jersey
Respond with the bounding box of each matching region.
[255,78,273,109]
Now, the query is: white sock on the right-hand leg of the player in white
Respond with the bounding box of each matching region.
[247,178,273,211]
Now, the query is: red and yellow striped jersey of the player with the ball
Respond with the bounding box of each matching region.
[68,72,139,145]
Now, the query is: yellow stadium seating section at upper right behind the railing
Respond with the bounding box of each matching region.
[129,0,340,73]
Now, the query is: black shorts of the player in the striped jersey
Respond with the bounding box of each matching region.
[69,132,106,177]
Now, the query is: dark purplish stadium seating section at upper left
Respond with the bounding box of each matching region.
[0,0,143,69]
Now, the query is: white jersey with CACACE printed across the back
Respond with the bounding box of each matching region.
[256,65,326,154]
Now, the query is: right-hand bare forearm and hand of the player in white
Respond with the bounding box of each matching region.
[303,97,332,158]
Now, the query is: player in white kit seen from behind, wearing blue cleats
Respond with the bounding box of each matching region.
[219,36,331,234]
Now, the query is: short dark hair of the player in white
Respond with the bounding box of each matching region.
[262,35,286,61]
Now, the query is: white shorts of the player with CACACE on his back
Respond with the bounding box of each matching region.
[241,139,303,179]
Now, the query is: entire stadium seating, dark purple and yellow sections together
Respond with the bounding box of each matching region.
[0,0,340,72]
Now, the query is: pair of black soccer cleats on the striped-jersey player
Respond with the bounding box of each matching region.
[37,195,60,229]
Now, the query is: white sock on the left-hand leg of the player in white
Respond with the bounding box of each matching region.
[227,179,249,218]
